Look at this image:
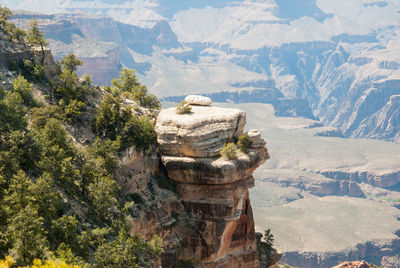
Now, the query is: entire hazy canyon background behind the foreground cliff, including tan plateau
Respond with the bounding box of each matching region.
[0,0,400,267]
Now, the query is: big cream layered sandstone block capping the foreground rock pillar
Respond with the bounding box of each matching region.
[155,106,246,157]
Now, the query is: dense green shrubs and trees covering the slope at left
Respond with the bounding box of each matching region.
[0,6,162,267]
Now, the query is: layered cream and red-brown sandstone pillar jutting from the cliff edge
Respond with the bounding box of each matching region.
[155,106,269,268]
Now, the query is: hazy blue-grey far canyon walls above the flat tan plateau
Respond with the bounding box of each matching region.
[6,0,400,142]
